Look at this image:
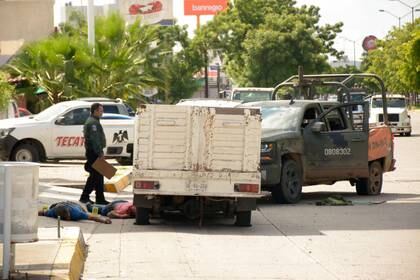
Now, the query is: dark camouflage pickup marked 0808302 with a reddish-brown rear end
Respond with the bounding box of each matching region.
[242,72,395,203]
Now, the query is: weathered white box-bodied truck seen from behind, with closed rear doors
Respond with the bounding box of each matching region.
[132,102,262,226]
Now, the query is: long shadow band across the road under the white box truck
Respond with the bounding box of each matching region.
[36,185,420,236]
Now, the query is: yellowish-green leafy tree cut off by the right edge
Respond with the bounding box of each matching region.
[363,19,420,93]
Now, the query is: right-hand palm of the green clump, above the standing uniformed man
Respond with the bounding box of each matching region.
[76,14,165,99]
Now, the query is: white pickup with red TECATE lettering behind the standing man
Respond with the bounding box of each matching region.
[0,101,134,164]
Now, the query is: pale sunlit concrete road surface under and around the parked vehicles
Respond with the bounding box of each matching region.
[39,111,420,280]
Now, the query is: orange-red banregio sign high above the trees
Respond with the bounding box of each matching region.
[184,0,227,16]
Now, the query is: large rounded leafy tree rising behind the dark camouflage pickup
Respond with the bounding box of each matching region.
[196,0,342,86]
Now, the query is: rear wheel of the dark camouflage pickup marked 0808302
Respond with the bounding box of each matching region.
[356,161,383,195]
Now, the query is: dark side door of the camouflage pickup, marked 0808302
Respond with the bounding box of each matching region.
[303,105,368,181]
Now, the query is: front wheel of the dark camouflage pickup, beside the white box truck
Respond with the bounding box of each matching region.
[271,159,302,204]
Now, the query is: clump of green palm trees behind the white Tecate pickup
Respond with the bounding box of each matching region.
[8,14,164,103]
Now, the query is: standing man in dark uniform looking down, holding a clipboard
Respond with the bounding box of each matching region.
[79,103,109,204]
